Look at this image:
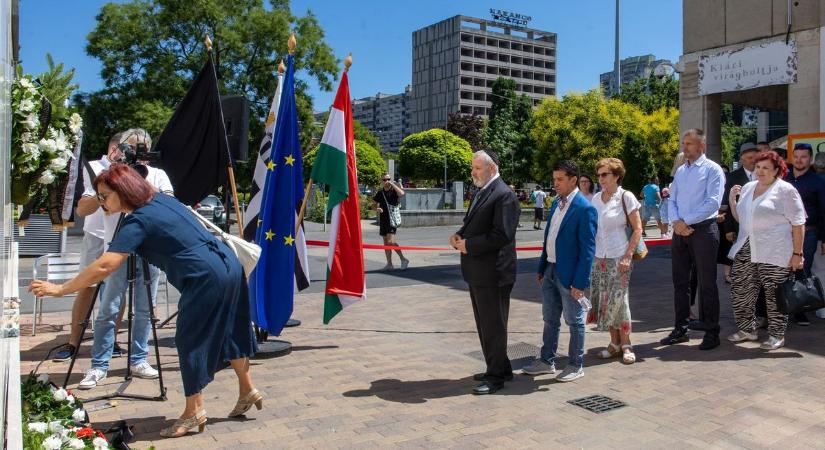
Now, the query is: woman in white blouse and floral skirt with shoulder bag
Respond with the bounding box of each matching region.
[590,158,642,364]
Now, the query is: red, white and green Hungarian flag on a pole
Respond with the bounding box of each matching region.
[311,72,367,324]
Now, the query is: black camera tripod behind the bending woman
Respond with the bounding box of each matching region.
[63,214,166,402]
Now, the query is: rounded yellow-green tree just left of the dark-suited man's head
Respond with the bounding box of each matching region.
[398,128,473,185]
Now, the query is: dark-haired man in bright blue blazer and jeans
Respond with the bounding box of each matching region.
[523,161,598,382]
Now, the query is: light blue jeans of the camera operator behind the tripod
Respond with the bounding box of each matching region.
[92,258,160,370]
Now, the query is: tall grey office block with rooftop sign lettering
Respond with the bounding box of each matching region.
[408,14,556,133]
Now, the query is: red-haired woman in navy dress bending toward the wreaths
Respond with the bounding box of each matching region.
[29,164,263,437]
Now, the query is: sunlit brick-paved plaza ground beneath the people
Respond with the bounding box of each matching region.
[14,221,825,449]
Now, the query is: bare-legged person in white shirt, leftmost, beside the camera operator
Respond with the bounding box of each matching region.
[54,133,123,361]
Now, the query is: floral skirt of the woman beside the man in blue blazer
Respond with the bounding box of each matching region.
[590,258,633,333]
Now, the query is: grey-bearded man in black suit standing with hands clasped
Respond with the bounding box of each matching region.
[450,150,520,395]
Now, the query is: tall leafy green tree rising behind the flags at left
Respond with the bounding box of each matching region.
[81,0,338,174]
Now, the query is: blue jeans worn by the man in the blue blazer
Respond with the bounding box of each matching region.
[541,263,587,367]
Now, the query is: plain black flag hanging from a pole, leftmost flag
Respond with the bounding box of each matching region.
[154,58,229,205]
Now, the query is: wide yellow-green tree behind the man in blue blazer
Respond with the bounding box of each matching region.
[531,90,679,191]
